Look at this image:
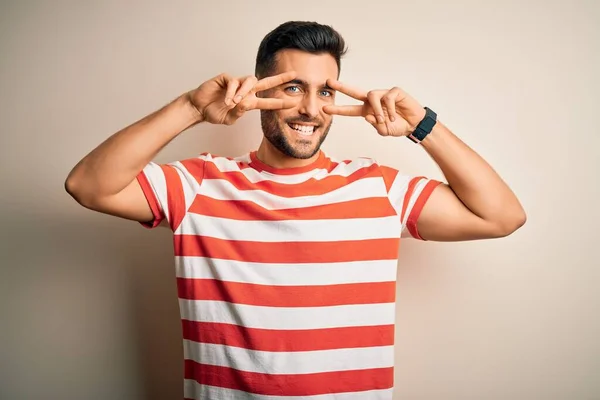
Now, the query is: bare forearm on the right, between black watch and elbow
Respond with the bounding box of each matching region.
[421,122,525,226]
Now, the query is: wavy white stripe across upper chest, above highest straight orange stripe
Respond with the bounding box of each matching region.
[200,177,387,210]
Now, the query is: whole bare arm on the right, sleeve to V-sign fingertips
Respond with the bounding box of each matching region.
[325,81,526,241]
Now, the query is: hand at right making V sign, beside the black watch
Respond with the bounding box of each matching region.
[323,79,425,136]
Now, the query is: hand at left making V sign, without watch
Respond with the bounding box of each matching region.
[188,71,296,125]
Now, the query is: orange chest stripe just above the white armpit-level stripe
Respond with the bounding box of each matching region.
[189,195,396,221]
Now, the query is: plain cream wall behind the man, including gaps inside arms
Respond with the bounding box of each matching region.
[0,0,600,400]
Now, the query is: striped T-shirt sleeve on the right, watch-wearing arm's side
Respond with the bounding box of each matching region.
[381,167,442,240]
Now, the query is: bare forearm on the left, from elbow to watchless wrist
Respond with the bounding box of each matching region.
[65,95,199,197]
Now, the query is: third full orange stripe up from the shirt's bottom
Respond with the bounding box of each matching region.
[177,278,396,307]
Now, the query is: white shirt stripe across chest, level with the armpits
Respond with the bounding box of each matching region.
[177,213,401,242]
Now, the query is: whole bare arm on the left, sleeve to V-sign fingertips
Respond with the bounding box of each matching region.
[65,72,295,222]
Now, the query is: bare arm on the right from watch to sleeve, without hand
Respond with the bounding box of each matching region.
[417,122,526,241]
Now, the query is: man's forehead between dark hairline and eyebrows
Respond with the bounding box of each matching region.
[274,49,338,85]
